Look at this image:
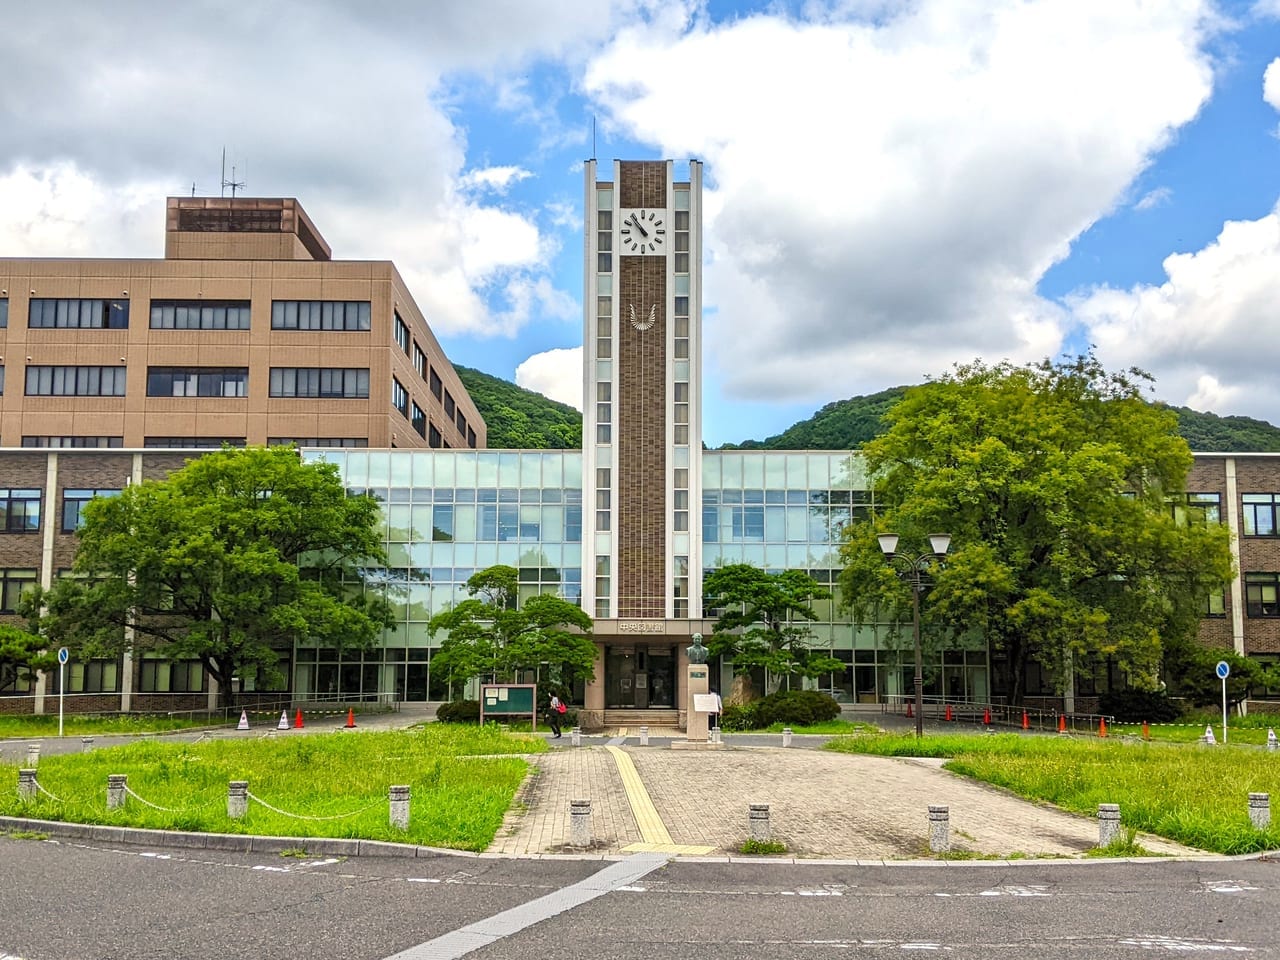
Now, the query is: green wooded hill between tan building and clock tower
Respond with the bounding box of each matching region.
[453,365,582,451]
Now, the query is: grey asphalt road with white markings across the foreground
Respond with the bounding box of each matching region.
[0,837,1280,960]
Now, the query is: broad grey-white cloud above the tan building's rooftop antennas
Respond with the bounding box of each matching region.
[0,0,634,335]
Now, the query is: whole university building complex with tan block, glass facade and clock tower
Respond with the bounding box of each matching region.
[0,161,1280,727]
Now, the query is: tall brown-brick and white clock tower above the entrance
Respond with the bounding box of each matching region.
[582,160,701,627]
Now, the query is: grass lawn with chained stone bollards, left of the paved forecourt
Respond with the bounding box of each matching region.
[0,723,547,850]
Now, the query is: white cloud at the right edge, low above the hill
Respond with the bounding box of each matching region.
[1070,204,1280,420]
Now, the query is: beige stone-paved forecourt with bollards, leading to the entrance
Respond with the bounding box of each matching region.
[488,736,1199,860]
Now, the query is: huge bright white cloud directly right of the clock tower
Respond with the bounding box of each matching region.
[585,0,1216,399]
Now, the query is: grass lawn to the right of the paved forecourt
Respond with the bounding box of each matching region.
[827,733,1280,854]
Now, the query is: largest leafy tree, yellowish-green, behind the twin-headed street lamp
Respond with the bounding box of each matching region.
[840,355,1231,703]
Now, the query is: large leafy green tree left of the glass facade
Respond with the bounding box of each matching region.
[40,447,390,698]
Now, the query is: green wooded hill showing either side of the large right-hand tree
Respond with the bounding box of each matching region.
[721,387,1280,453]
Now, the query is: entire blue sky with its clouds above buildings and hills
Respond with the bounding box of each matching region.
[0,0,1280,445]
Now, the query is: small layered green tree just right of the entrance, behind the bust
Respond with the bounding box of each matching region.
[703,563,845,680]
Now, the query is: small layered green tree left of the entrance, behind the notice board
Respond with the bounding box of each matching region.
[429,564,595,685]
